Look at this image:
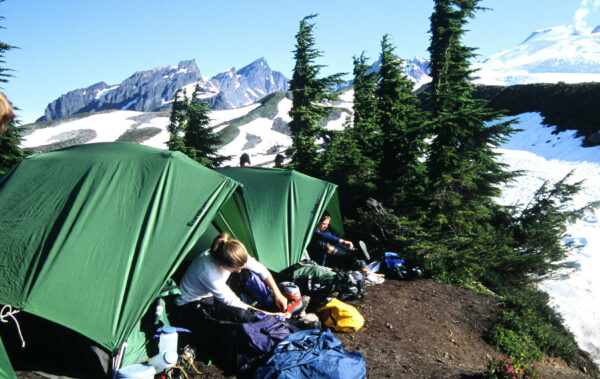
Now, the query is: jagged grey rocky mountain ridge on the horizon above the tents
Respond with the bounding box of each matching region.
[37,58,288,122]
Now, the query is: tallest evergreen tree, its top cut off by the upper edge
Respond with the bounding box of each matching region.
[426,0,517,280]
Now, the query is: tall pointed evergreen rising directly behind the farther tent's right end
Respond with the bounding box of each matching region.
[287,14,342,176]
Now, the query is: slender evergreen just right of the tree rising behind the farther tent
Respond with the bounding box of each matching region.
[351,52,381,161]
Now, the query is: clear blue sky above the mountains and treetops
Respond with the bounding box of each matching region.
[0,0,600,122]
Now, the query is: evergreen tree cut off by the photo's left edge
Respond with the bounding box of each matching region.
[0,5,26,175]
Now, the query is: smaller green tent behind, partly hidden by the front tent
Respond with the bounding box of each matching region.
[217,167,343,271]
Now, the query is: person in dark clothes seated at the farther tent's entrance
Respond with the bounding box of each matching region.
[311,214,370,273]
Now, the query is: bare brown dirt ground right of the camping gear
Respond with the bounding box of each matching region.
[18,280,590,378]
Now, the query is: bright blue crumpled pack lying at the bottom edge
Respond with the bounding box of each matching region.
[252,329,367,379]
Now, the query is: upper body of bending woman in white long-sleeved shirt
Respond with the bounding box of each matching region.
[175,233,287,313]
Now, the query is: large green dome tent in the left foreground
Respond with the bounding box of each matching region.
[0,143,255,372]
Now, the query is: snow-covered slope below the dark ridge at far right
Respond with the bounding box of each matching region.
[500,113,600,364]
